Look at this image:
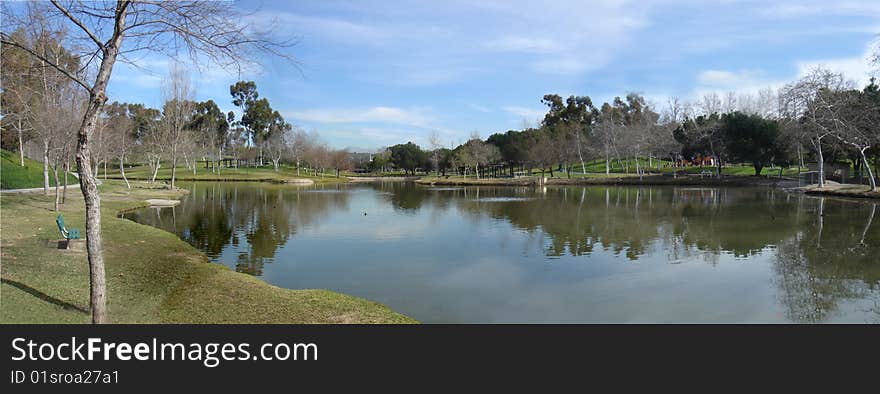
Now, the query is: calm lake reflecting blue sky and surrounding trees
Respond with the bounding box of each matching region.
[125,182,880,323]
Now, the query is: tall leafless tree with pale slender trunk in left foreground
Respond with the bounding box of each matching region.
[0,0,296,323]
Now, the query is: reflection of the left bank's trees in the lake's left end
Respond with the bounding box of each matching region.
[124,183,349,276]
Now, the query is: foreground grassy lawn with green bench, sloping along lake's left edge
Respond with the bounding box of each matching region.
[0,181,415,323]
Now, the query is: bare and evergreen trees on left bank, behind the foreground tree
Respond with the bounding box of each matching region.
[0,25,351,194]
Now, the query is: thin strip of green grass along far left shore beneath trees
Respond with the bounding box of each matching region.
[98,165,346,183]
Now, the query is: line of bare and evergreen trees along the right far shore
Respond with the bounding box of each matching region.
[368,67,880,190]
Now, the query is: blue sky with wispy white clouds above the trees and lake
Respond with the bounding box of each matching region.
[109,0,880,150]
